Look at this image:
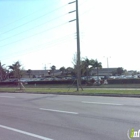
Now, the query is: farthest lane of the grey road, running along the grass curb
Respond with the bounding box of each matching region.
[0,93,140,106]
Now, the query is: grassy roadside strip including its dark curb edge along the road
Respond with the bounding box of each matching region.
[0,88,140,97]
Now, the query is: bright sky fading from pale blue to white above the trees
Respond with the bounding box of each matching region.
[0,0,140,71]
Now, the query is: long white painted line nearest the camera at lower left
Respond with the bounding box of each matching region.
[0,125,53,140]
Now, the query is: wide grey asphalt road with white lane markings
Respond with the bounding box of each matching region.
[0,93,140,140]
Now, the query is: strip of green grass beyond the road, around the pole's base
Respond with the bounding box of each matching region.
[0,87,140,95]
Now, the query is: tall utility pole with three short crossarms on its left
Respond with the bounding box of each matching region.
[69,0,81,91]
